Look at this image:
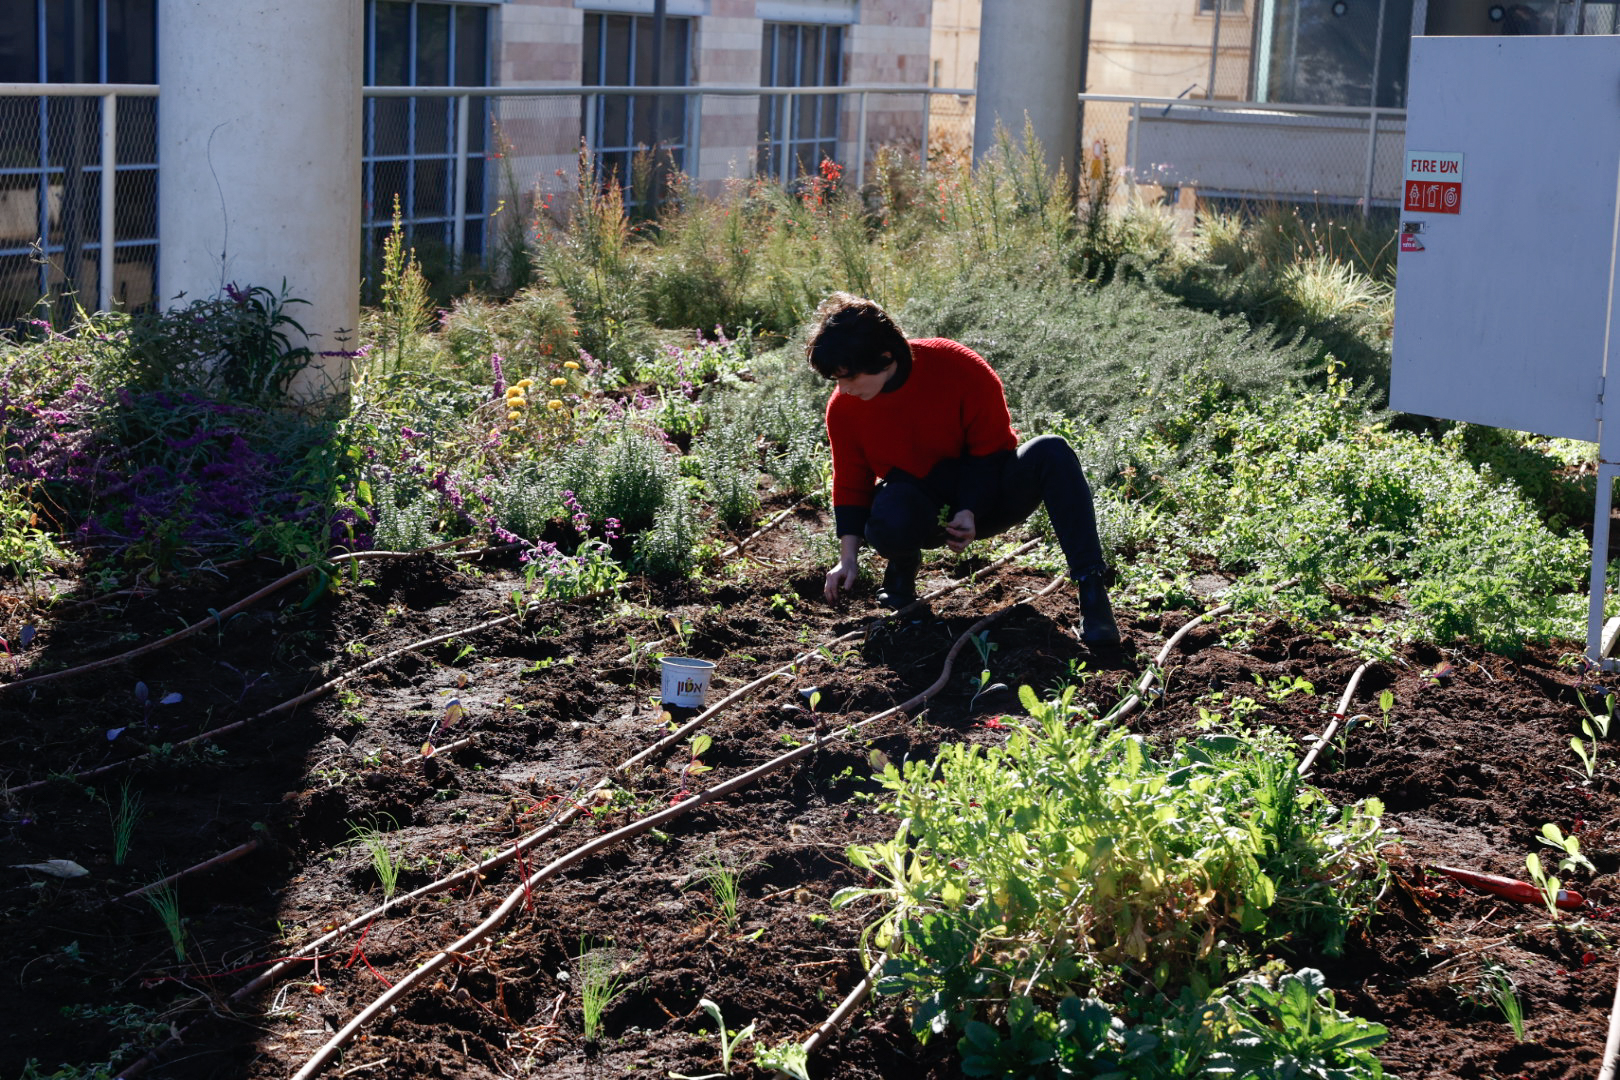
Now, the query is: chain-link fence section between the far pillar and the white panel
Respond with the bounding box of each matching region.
[1081,94,1406,227]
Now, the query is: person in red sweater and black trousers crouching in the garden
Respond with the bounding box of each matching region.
[805,293,1119,644]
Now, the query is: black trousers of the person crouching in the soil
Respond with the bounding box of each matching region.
[867,436,1103,578]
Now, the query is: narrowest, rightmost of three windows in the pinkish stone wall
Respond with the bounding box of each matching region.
[760,23,844,183]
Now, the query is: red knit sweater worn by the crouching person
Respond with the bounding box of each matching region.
[826,337,1017,531]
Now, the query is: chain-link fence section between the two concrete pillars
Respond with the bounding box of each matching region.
[363,86,972,286]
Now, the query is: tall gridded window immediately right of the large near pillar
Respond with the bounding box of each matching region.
[361,0,492,272]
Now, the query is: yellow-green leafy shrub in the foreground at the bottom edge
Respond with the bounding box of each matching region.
[834,688,1385,1077]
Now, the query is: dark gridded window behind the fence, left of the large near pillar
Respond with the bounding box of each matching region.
[0,0,157,322]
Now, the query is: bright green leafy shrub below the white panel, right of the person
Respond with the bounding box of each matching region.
[1165,375,1586,651]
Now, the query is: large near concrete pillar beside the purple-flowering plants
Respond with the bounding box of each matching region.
[157,0,363,402]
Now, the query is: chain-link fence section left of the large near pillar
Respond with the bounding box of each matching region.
[0,84,157,325]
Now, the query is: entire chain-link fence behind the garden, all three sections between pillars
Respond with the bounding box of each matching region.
[0,84,1406,324]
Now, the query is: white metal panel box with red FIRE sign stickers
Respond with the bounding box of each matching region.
[1390,37,1620,446]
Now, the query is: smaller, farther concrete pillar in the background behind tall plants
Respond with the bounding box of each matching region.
[974,0,1089,175]
